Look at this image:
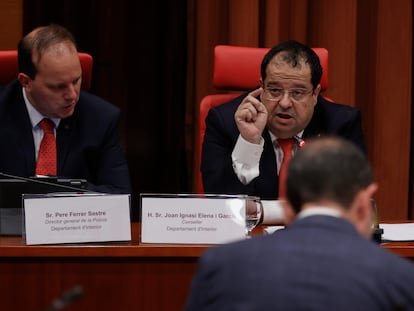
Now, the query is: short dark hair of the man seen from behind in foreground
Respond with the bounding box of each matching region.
[287,136,373,213]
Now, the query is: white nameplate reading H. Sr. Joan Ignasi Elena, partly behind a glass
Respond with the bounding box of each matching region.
[141,195,246,244]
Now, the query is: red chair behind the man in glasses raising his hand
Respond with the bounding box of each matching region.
[196,45,328,193]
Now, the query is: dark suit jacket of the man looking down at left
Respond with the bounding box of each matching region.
[0,80,131,193]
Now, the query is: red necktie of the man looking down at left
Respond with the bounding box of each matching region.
[36,118,57,176]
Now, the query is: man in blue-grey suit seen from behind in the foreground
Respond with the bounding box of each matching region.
[184,137,414,311]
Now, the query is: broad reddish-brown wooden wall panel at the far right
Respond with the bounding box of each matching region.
[367,0,412,219]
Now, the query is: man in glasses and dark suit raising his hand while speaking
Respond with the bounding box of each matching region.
[201,41,365,199]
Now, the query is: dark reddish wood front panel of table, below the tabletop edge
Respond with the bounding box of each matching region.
[0,258,196,311]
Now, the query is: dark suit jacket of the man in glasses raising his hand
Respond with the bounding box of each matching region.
[201,93,365,199]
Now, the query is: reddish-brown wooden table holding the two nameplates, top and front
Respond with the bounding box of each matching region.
[0,223,414,311]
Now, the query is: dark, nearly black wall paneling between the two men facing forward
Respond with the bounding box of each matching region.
[24,0,191,219]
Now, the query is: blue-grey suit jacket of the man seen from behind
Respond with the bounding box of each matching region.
[184,215,414,311]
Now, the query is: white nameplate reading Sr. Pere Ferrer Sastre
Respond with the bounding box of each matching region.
[23,193,131,245]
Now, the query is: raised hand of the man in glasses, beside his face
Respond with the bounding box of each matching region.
[234,88,267,144]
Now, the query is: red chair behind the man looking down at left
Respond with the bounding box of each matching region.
[0,50,93,91]
